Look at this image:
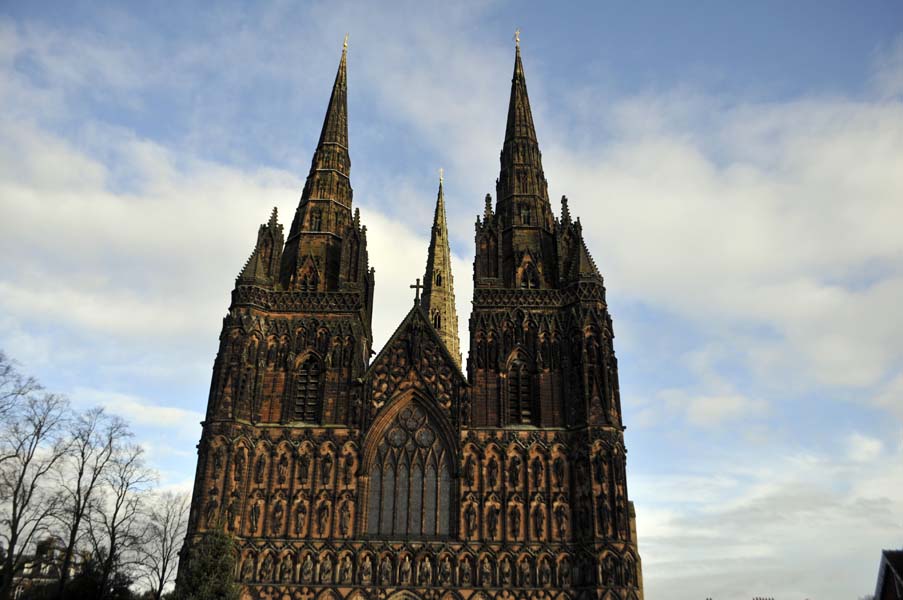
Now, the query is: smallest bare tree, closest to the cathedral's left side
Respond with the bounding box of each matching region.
[138,492,190,600]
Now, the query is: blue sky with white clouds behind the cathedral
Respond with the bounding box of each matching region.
[0,0,903,600]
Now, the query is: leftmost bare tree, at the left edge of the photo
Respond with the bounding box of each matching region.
[0,389,69,600]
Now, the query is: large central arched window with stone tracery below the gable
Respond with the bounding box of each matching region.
[367,406,452,537]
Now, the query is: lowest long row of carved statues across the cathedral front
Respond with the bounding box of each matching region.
[237,551,638,588]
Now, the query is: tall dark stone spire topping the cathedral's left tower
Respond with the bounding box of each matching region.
[280,37,352,288]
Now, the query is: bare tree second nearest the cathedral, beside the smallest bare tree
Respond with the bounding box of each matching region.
[91,444,154,597]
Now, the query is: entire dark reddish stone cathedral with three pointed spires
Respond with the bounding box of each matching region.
[186,36,643,600]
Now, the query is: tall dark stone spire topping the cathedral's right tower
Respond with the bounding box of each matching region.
[496,36,553,231]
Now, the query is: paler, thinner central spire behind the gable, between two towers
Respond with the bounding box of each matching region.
[421,169,461,369]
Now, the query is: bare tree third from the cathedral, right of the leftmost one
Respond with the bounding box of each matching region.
[57,408,132,595]
